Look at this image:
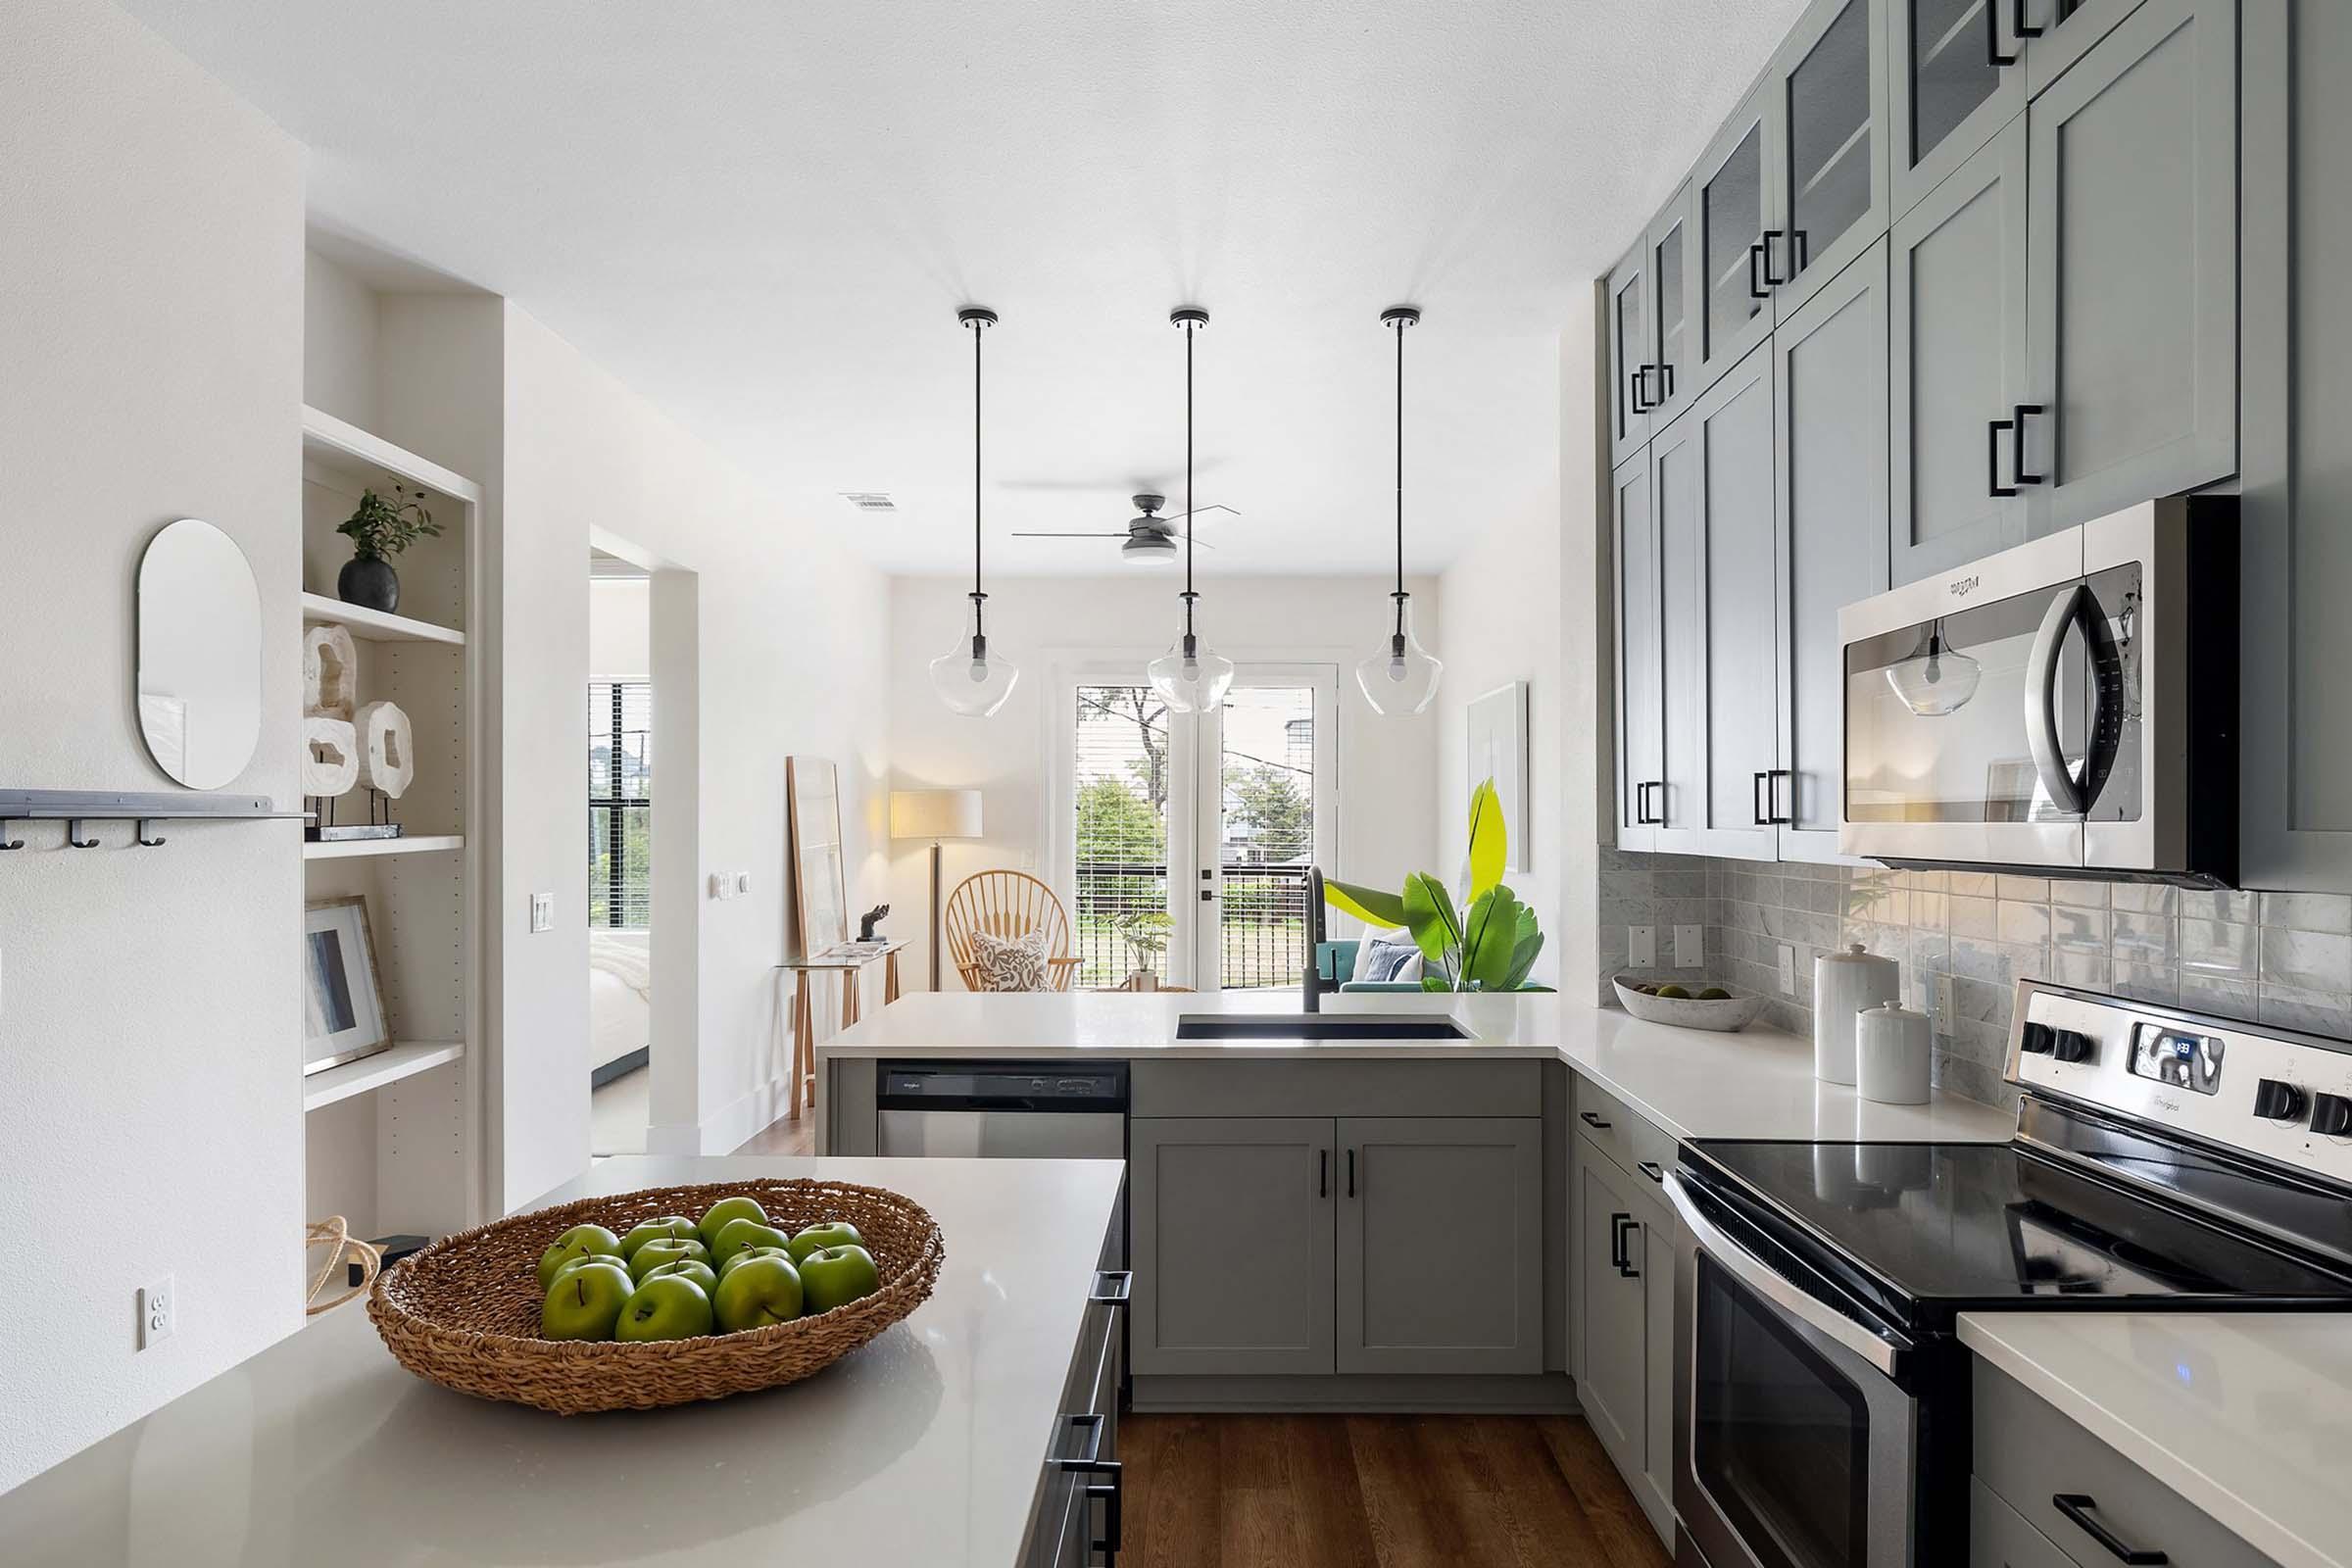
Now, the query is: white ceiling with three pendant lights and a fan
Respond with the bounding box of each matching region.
[124,0,1801,573]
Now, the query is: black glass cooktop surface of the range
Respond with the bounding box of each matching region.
[1691,1136,2352,1321]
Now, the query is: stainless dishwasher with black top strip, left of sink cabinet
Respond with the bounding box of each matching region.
[875,1062,1127,1159]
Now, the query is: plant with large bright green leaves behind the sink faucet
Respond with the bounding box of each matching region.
[1324,778,1550,992]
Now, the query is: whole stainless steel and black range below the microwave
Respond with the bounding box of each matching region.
[1665,980,2352,1568]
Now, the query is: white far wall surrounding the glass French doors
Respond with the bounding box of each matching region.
[880,571,1430,990]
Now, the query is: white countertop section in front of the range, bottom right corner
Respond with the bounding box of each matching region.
[1959,1312,2352,1568]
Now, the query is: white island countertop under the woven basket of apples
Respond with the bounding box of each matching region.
[0,1156,1124,1568]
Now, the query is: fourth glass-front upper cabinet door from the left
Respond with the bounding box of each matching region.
[1766,0,1888,322]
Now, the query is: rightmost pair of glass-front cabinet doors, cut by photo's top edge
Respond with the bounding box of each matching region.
[1886,0,2140,217]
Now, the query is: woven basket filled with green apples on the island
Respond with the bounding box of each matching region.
[367,1180,948,1415]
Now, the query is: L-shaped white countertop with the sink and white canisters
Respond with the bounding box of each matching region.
[816,992,2016,1143]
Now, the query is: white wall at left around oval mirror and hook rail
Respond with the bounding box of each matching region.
[0,0,304,1491]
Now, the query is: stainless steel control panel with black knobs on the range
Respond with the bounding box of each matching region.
[2009,980,2352,1180]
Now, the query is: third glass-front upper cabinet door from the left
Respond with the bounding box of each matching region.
[1684,77,1788,397]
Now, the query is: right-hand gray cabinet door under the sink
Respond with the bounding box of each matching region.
[1339,1116,1543,1373]
